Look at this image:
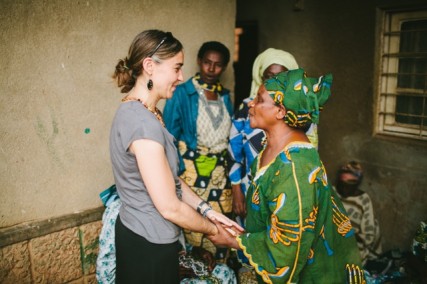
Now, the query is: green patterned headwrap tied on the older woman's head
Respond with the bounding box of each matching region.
[264,68,332,128]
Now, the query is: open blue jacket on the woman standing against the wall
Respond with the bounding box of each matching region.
[163,77,233,173]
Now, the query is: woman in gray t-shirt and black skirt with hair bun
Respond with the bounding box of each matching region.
[110,30,242,283]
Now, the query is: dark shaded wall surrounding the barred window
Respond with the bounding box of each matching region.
[237,0,427,250]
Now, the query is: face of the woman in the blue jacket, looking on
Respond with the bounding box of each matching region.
[197,50,227,84]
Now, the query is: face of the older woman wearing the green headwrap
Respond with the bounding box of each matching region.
[248,85,280,129]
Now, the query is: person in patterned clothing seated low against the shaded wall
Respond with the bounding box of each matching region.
[335,161,382,264]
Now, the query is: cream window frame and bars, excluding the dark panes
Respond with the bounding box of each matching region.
[374,6,427,142]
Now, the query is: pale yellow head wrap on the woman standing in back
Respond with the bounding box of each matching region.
[249,48,298,98]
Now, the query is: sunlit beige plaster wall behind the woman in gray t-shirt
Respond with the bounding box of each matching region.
[0,0,236,228]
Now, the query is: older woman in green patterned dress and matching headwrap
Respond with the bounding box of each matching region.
[209,69,365,284]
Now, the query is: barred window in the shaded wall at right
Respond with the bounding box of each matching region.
[376,9,427,141]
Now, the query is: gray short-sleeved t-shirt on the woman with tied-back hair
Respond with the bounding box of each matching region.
[110,101,182,244]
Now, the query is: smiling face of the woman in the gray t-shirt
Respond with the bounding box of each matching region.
[151,51,184,99]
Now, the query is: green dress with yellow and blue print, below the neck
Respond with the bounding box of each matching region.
[237,142,364,283]
